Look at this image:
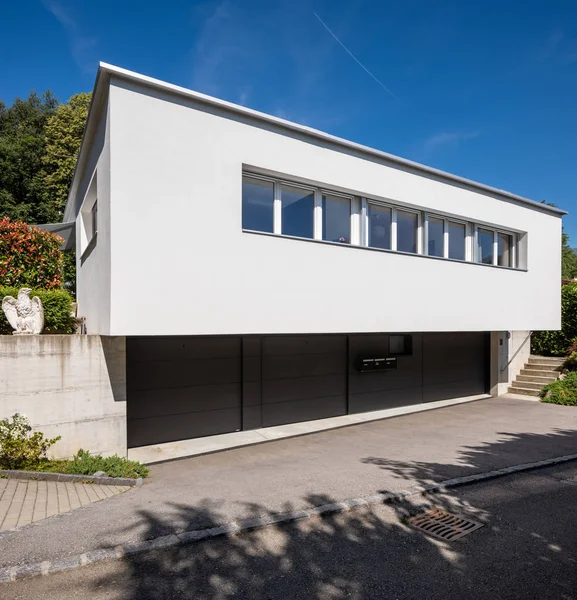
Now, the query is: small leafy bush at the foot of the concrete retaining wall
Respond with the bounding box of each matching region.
[0,413,60,469]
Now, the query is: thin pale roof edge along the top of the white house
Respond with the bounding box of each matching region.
[65,62,567,218]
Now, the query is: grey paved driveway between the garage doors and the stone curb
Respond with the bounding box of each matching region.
[0,398,577,567]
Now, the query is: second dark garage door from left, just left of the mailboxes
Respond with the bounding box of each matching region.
[262,335,347,427]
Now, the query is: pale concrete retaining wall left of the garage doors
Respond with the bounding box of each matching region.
[0,335,126,458]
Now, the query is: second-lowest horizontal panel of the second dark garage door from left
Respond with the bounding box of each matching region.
[262,374,346,404]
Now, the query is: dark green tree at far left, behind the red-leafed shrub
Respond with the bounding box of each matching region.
[0,91,58,223]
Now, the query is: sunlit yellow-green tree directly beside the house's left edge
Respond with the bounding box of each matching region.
[42,93,92,220]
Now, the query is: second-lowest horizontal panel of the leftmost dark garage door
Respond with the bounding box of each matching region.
[127,383,240,419]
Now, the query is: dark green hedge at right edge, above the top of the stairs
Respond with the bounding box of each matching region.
[531,283,577,356]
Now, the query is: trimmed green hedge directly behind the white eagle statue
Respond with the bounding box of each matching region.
[0,287,77,334]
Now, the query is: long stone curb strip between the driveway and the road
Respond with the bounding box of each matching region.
[0,454,577,583]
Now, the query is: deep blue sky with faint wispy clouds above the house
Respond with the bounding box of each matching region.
[0,0,577,241]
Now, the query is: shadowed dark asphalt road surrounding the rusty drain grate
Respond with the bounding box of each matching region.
[0,462,577,600]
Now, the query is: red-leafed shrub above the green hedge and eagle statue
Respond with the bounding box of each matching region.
[0,217,62,290]
